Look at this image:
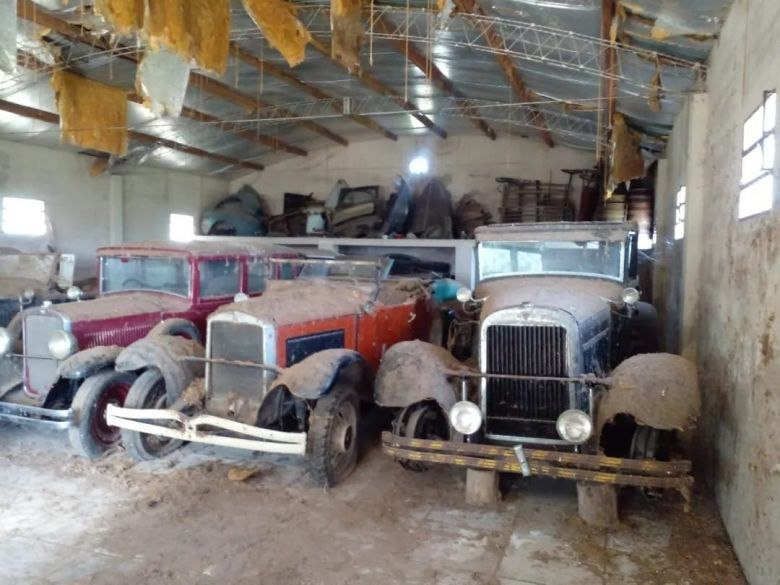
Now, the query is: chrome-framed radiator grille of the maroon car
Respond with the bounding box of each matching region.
[24,314,65,394]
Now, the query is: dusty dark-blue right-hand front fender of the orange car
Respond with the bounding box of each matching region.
[268,349,367,400]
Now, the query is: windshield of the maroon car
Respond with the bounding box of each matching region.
[100,256,190,297]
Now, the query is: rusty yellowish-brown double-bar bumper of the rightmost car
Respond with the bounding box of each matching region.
[382,432,693,490]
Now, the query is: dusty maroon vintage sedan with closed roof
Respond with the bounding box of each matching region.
[0,241,298,457]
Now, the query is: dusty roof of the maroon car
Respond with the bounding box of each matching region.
[97,238,300,257]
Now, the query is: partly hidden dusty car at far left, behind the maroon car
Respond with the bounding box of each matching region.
[0,250,75,327]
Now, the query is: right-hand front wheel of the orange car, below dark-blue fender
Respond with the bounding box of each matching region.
[306,384,360,487]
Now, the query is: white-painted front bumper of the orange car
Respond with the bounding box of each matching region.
[106,404,306,455]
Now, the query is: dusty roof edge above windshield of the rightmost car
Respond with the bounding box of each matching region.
[474,221,637,242]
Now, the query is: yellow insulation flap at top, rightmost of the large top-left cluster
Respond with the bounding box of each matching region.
[186,0,230,75]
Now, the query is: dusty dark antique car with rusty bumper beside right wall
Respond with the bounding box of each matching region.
[375,223,699,502]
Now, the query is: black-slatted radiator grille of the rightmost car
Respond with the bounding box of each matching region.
[485,325,570,439]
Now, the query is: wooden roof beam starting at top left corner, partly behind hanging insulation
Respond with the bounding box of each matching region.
[16,0,349,150]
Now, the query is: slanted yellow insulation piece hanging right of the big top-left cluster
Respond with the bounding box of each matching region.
[243,0,311,67]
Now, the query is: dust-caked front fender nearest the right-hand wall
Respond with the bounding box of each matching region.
[596,353,701,436]
